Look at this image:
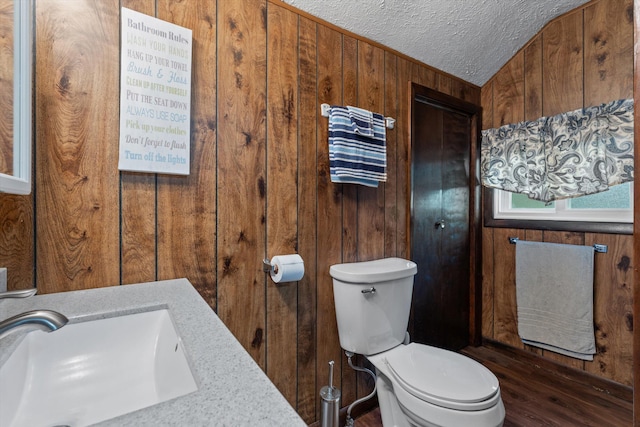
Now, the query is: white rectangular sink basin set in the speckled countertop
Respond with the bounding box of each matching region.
[0,309,197,427]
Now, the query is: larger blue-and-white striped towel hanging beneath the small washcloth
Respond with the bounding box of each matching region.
[329,106,387,187]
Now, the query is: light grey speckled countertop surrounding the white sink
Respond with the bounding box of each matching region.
[0,279,306,427]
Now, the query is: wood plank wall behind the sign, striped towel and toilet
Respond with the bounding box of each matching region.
[0,0,480,423]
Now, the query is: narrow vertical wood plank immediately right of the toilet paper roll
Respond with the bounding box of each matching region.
[297,17,320,424]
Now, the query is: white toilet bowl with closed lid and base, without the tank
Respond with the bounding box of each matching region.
[367,343,505,427]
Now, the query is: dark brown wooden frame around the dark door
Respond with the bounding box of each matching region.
[406,82,482,346]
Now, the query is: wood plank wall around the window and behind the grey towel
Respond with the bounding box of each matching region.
[481,0,634,386]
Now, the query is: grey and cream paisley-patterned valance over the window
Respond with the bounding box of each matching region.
[480,99,633,202]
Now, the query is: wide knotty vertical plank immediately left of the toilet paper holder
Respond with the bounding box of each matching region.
[217,0,267,369]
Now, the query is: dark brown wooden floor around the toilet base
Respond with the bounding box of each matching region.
[355,345,633,427]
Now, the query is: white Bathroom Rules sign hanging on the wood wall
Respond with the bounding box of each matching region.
[118,7,192,175]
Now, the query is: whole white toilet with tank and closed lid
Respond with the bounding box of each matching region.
[329,258,505,427]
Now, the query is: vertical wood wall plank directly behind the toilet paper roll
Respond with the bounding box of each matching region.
[266,4,298,407]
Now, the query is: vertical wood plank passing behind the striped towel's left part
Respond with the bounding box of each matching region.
[317,25,342,418]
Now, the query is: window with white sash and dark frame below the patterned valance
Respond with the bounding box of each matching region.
[485,182,633,234]
